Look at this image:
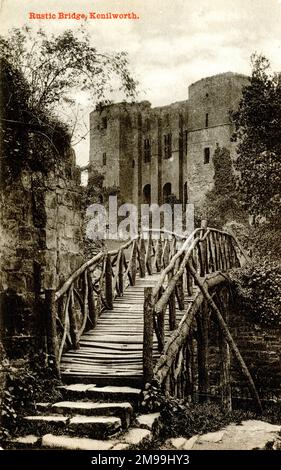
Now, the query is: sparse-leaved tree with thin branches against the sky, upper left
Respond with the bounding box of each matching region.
[0,27,136,143]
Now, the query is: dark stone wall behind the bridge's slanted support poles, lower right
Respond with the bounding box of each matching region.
[209,302,281,405]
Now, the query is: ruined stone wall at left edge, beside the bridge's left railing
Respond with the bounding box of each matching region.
[0,154,83,355]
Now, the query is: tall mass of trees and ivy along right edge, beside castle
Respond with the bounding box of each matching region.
[197,54,281,326]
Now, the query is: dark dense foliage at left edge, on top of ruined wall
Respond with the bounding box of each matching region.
[0,60,70,185]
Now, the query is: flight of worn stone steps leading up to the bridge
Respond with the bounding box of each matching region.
[10,383,159,450]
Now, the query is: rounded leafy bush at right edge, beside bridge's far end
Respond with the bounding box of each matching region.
[231,259,281,327]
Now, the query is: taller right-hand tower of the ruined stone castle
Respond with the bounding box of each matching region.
[187,72,248,204]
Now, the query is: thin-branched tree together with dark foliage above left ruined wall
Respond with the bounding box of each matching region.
[0,27,136,186]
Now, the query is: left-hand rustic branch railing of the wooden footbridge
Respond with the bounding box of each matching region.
[45,230,182,375]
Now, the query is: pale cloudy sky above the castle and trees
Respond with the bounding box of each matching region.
[0,0,281,165]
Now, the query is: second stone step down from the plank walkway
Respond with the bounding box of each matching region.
[36,401,133,429]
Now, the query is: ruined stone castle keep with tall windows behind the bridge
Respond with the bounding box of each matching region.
[90,72,248,204]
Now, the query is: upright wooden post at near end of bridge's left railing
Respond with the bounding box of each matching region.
[45,289,60,377]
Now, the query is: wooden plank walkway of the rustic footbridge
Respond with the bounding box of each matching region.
[61,273,183,385]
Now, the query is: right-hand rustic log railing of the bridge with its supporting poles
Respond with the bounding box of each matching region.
[143,225,261,410]
